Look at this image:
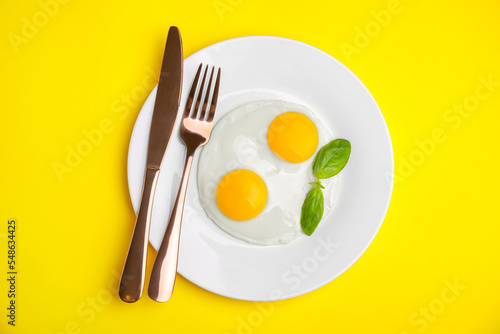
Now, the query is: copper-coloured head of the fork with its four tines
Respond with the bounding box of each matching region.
[180,64,221,148]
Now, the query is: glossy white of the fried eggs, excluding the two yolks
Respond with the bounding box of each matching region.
[198,101,336,245]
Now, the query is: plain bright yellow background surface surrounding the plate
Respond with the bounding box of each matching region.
[0,0,500,334]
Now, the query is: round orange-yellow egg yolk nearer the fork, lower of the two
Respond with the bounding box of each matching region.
[215,169,267,220]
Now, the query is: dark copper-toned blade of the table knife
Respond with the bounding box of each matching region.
[147,27,183,169]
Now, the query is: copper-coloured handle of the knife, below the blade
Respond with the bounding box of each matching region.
[118,167,160,303]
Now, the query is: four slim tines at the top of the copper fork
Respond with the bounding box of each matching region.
[184,64,220,122]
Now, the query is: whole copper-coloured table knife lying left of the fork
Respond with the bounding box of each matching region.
[118,27,183,303]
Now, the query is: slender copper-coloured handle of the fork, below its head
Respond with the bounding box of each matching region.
[148,149,195,302]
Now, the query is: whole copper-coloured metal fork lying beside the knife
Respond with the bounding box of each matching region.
[148,64,221,302]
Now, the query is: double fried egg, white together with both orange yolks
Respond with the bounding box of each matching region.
[198,101,336,245]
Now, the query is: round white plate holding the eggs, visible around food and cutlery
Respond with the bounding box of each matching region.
[128,36,394,301]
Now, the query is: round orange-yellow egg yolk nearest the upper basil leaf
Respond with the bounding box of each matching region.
[267,111,318,163]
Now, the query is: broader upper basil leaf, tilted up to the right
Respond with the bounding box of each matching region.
[313,139,351,179]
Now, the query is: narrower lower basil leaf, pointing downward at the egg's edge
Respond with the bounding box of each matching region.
[300,185,325,235]
